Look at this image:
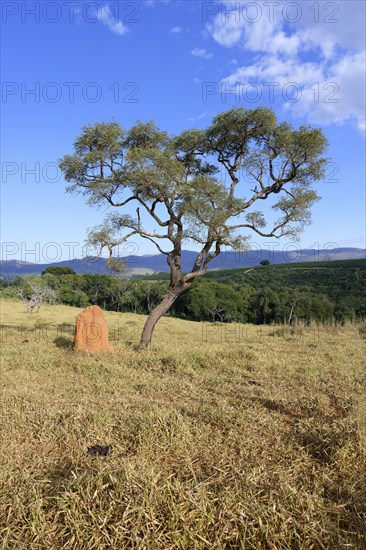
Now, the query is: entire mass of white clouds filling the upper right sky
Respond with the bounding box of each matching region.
[207,0,365,130]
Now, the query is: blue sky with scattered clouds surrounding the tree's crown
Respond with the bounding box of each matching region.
[1,0,365,263]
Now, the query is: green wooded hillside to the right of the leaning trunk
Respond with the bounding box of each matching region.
[142,260,366,324]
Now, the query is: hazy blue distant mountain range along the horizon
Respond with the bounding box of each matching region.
[0,246,366,278]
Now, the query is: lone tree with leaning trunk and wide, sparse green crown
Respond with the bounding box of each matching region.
[60,108,327,348]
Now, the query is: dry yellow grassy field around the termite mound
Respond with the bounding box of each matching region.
[0,301,366,550]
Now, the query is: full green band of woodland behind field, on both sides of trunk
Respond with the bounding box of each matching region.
[2,260,366,324]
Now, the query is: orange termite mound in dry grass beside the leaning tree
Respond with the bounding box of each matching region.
[74,306,113,351]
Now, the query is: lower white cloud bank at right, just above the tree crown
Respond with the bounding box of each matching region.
[222,52,366,130]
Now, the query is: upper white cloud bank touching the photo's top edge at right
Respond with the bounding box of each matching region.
[207,0,366,54]
